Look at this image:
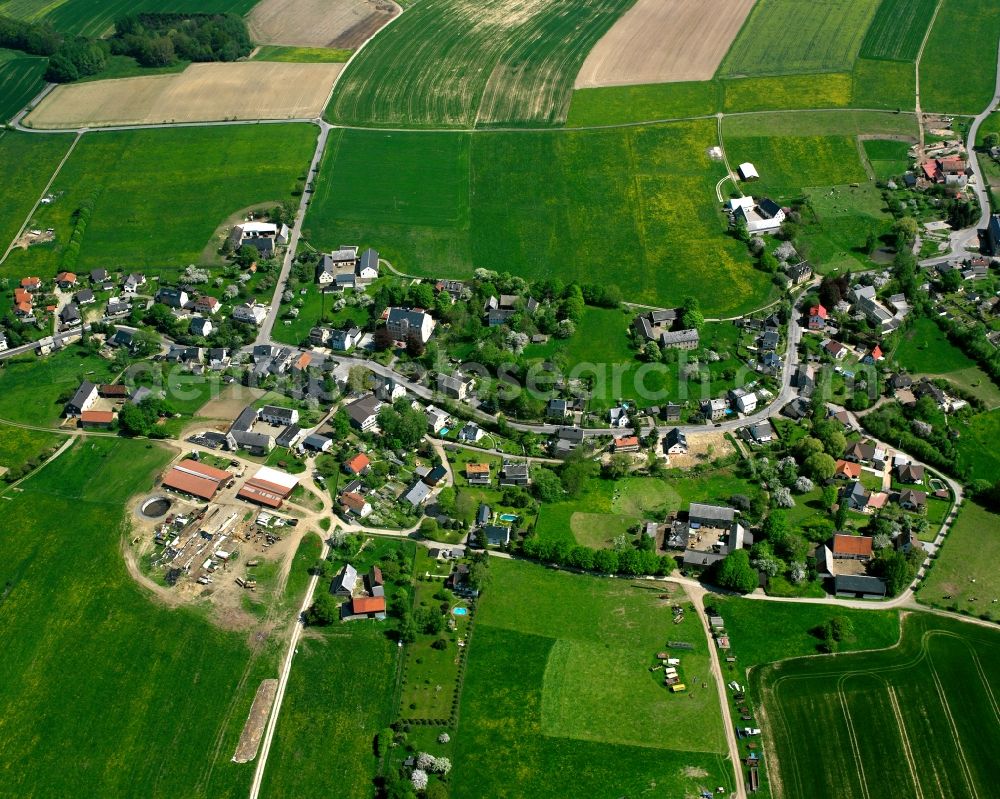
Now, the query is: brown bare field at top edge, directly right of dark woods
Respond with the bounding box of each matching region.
[248,0,400,50]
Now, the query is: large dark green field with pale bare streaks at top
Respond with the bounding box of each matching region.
[327,0,633,128]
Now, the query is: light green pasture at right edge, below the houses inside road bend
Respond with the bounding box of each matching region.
[917,502,1000,620]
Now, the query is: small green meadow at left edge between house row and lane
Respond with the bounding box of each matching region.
[0,346,112,426]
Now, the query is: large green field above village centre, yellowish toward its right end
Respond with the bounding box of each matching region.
[305,123,772,314]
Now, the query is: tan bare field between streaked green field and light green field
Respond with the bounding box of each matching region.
[575,0,755,89]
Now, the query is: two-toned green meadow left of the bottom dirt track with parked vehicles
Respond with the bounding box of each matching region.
[451,560,732,799]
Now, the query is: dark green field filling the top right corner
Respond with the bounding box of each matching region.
[920,0,1000,114]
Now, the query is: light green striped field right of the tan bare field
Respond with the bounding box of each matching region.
[720,0,877,76]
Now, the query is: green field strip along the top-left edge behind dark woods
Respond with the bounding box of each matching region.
[0,0,257,36]
